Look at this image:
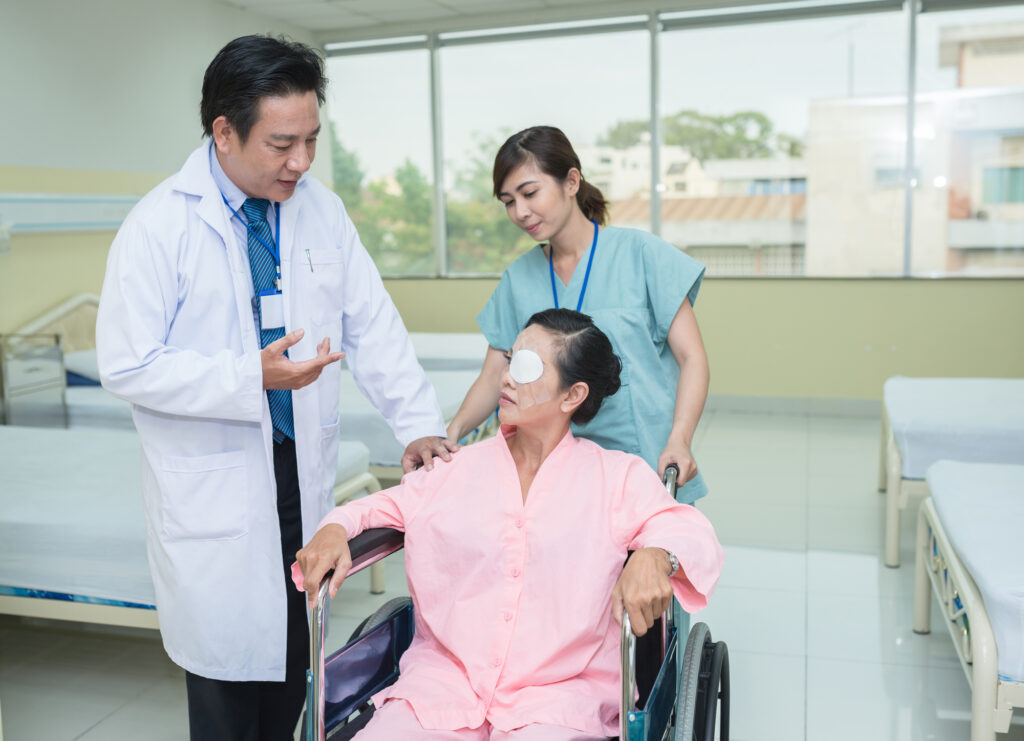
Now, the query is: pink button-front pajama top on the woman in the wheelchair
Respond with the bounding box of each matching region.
[321,427,723,736]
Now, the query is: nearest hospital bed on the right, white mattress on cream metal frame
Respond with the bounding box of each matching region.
[913,461,1024,741]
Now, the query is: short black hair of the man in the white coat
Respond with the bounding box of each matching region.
[199,35,327,144]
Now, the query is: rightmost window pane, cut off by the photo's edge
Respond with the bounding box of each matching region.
[911,6,1024,275]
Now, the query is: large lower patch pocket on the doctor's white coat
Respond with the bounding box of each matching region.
[156,450,250,540]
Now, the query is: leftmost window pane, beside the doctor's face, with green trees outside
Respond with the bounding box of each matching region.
[327,49,437,275]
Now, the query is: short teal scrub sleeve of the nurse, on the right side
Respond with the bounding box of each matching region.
[643,237,705,342]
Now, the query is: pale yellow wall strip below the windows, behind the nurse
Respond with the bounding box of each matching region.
[386,278,1024,399]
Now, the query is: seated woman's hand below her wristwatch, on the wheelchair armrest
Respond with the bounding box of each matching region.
[611,548,672,636]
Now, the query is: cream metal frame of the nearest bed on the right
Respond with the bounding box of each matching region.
[913,496,1024,741]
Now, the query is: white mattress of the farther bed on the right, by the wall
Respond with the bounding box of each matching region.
[885,376,1024,479]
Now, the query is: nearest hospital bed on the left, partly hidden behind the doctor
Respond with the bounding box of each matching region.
[0,426,384,627]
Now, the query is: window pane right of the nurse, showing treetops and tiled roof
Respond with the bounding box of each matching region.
[660,11,906,276]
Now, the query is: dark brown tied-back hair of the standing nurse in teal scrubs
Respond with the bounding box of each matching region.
[492,126,608,224]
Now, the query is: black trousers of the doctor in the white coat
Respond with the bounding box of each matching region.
[185,438,309,741]
